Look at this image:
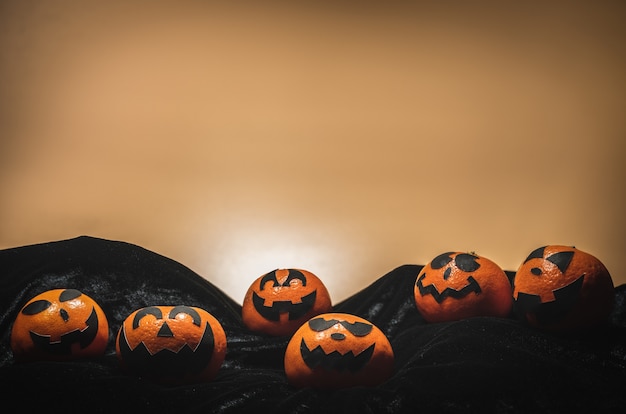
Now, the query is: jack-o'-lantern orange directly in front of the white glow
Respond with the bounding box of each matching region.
[241,269,332,336]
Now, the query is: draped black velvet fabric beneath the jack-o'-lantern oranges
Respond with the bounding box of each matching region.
[0,236,626,414]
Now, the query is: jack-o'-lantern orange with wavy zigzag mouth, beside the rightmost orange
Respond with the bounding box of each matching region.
[414,252,512,322]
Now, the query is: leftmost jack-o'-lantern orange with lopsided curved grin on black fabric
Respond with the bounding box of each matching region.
[11,289,109,360]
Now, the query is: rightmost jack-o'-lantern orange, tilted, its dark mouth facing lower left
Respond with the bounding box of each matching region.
[513,245,614,331]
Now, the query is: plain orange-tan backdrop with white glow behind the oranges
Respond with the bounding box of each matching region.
[0,0,626,302]
